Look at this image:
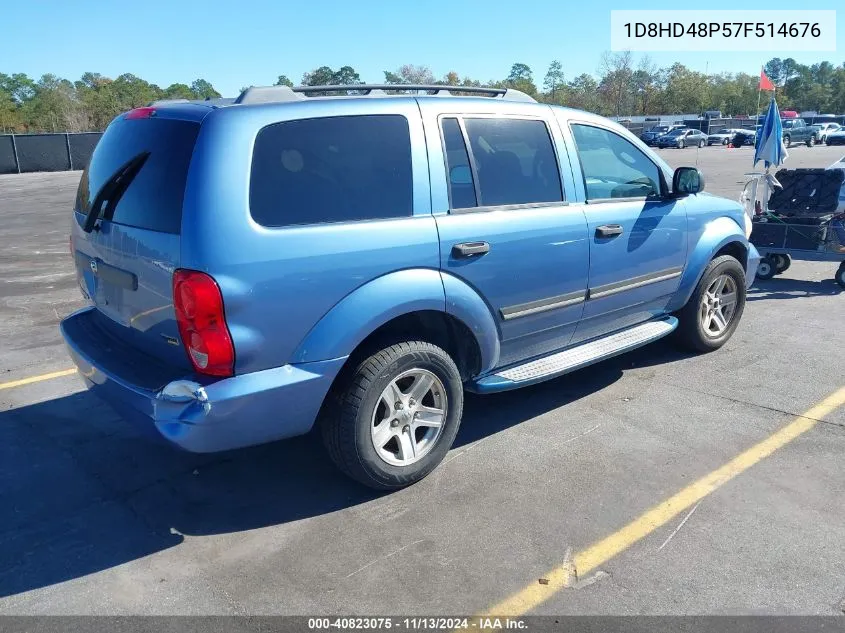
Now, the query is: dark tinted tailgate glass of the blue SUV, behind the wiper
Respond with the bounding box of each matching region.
[75,117,200,233]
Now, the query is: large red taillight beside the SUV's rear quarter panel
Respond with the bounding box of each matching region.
[173,269,235,376]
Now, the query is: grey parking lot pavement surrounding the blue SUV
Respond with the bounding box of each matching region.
[0,146,845,615]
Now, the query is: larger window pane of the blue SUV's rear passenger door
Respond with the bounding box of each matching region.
[464,118,563,206]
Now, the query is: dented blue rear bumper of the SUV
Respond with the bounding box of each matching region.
[60,308,346,453]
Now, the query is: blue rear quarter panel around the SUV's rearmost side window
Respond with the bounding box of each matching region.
[181,98,443,373]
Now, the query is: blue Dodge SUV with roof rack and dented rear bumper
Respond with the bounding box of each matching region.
[61,85,759,489]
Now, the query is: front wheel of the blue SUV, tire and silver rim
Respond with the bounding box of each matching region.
[677,255,745,352]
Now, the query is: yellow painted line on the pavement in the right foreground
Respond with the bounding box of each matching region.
[487,387,845,616]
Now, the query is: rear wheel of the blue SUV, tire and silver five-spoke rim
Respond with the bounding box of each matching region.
[320,341,464,490]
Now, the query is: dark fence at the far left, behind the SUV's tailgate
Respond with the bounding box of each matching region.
[0,132,103,174]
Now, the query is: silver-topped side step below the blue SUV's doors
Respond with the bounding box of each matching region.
[470,317,678,393]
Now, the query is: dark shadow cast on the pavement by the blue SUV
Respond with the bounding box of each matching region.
[0,343,684,596]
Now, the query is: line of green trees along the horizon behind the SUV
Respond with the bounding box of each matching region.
[0,52,845,133]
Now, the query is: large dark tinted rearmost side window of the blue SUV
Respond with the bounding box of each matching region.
[250,114,413,227]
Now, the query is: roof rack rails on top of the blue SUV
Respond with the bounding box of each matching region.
[235,84,536,105]
